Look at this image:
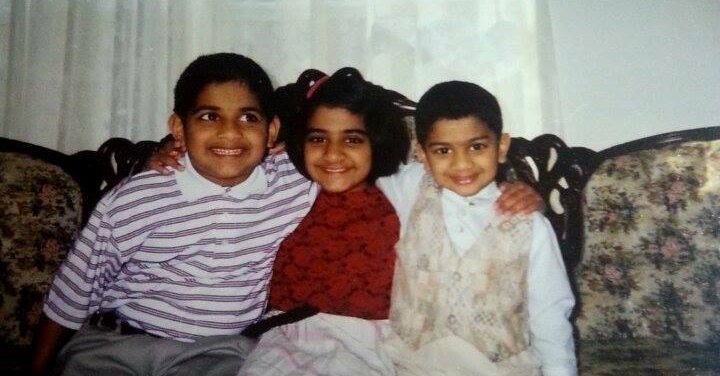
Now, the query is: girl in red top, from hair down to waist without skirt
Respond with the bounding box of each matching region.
[270,68,410,319]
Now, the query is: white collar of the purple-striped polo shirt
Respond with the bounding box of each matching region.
[175,154,267,201]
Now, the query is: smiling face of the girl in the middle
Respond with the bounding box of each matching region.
[304,106,372,193]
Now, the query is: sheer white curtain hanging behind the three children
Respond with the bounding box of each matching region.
[0,0,559,152]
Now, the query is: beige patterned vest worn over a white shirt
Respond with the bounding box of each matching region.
[390,176,538,369]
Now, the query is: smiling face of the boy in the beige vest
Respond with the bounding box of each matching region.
[420,116,510,196]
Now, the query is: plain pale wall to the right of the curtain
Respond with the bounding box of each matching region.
[548,0,720,150]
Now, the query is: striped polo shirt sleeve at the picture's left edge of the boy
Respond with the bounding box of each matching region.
[43,195,121,330]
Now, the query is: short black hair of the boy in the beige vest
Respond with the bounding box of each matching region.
[415,81,502,146]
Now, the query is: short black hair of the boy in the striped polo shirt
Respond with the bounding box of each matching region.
[173,52,275,121]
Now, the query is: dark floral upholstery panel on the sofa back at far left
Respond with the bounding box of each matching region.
[0,153,82,354]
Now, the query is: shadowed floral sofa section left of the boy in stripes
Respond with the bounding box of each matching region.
[0,138,154,376]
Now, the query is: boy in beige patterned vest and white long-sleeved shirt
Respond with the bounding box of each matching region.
[378,81,577,376]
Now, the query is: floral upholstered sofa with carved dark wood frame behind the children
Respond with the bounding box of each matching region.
[0,103,720,375]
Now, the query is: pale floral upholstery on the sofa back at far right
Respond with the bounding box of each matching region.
[576,140,720,375]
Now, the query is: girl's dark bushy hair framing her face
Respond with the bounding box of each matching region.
[276,67,410,184]
